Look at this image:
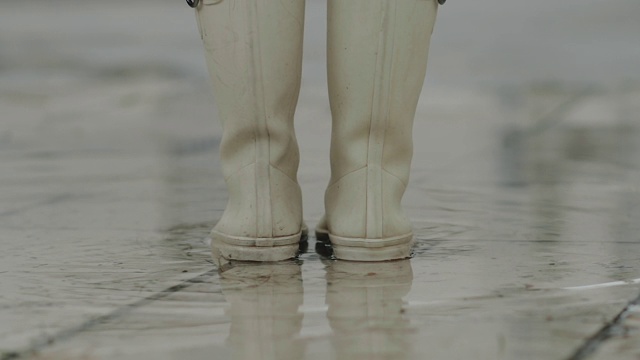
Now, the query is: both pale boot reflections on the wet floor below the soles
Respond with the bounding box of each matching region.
[220,260,413,359]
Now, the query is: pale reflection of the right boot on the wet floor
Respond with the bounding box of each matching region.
[327,260,413,360]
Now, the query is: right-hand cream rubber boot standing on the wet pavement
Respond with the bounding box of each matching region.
[316,0,438,261]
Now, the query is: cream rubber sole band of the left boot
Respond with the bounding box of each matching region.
[211,231,307,262]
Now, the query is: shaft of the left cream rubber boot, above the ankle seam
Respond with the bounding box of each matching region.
[198,0,305,179]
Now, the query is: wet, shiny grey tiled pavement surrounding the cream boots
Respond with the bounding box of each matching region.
[0,0,640,360]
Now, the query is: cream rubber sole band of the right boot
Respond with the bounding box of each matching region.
[316,229,414,261]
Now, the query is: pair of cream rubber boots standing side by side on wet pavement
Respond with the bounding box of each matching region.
[196,0,438,261]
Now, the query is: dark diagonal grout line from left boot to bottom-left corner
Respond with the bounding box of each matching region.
[0,269,218,360]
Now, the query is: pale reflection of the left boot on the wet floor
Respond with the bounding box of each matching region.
[220,262,304,360]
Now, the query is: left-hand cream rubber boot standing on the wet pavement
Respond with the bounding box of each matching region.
[197,0,305,261]
